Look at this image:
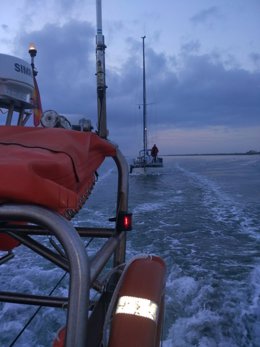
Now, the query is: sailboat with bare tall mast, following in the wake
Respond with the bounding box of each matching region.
[130,36,163,174]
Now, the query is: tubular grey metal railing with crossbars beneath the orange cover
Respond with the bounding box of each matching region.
[0,149,128,347]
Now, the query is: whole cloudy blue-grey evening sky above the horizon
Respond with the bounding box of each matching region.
[0,0,260,155]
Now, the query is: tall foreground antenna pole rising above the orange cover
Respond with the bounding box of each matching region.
[96,0,108,138]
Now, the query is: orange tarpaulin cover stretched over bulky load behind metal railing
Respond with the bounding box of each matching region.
[0,126,116,218]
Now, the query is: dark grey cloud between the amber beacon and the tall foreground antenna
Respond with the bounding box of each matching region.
[17,21,96,121]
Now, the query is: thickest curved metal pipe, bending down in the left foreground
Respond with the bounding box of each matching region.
[0,204,90,347]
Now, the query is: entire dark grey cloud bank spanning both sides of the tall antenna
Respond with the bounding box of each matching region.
[12,21,260,137]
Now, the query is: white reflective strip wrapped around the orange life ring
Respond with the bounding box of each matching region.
[116,296,158,322]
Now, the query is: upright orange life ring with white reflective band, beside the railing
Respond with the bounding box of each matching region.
[108,256,166,347]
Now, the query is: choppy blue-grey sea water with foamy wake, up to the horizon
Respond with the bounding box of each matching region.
[0,155,260,347]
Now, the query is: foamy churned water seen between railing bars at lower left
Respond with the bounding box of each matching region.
[0,260,68,347]
